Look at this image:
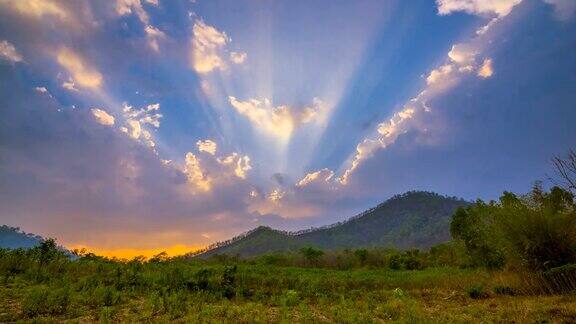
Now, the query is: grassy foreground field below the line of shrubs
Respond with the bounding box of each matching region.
[0,260,576,323]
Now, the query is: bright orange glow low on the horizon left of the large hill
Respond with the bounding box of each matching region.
[67,244,203,260]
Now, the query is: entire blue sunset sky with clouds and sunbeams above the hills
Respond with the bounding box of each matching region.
[0,0,576,257]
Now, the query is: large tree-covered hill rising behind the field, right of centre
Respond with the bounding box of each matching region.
[195,191,469,257]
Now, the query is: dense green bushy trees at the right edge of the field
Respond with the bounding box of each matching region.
[450,185,576,272]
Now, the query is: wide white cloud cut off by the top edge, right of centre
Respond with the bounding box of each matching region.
[436,0,522,17]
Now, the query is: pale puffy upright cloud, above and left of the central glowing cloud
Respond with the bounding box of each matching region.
[191,20,230,73]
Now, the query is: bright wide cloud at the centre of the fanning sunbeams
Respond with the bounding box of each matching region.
[228,96,327,140]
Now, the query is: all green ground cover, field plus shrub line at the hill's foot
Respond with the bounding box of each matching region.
[0,225,576,323]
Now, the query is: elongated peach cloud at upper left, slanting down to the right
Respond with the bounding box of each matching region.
[56,47,103,89]
